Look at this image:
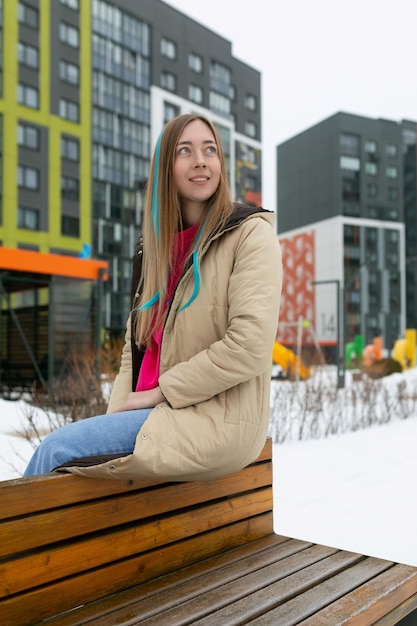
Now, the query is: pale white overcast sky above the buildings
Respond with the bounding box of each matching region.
[165,0,417,210]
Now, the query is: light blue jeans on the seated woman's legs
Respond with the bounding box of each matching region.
[23,409,152,476]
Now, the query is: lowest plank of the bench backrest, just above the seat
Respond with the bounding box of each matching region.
[0,512,274,626]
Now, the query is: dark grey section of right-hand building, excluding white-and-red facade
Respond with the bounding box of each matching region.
[277,112,417,348]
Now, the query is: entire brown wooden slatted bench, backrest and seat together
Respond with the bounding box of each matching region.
[0,440,417,626]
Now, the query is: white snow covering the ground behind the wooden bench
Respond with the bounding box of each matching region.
[0,370,417,566]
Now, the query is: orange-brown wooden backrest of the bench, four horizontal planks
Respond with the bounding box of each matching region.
[0,439,273,626]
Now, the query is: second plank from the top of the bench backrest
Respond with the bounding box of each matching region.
[0,463,272,556]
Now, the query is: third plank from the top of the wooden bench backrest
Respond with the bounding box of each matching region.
[0,487,272,597]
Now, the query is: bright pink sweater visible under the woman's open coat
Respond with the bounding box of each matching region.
[136,224,199,391]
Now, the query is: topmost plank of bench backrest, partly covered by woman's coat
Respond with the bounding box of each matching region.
[0,438,272,520]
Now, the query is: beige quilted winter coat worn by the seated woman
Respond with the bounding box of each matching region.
[65,208,282,481]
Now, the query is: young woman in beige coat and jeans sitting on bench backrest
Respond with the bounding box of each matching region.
[25,114,282,481]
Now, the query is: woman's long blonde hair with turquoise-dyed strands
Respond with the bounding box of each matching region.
[135,113,233,347]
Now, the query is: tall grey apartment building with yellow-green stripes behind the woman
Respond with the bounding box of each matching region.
[0,0,262,334]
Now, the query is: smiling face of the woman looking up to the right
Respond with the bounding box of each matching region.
[174,120,221,209]
